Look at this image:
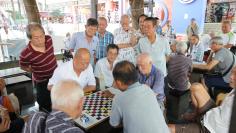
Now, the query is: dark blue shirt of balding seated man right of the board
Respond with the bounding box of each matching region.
[138,65,165,101]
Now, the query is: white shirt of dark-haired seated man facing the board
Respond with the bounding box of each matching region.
[94,57,115,87]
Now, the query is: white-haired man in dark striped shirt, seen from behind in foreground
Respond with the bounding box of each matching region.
[23,80,84,133]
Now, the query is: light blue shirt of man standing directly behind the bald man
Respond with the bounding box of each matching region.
[69,32,98,65]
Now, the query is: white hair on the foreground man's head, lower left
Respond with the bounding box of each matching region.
[51,80,84,109]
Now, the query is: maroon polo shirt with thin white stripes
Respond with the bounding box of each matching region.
[19,36,57,82]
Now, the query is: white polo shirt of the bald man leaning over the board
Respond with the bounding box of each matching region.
[48,60,96,88]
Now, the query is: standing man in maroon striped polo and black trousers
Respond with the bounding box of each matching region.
[19,23,57,112]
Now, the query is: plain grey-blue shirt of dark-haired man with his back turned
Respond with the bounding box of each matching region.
[110,82,169,133]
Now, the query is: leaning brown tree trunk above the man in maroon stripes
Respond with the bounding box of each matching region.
[23,0,41,24]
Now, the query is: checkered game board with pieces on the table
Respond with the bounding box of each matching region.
[75,91,112,129]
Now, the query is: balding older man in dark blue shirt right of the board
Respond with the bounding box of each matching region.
[137,53,165,105]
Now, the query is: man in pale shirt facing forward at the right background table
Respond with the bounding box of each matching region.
[188,34,204,62]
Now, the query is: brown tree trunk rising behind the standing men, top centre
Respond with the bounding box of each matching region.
[129,0,144,30]
